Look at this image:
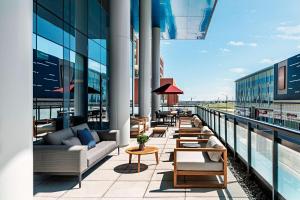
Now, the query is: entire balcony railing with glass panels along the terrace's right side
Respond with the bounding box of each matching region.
[197,107,300,199]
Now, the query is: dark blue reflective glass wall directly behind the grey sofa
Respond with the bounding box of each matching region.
[32,0,109,134]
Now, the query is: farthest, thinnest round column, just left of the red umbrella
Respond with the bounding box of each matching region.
[152,27,160,118]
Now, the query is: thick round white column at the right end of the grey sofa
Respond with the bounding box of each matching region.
[109,0,130,146]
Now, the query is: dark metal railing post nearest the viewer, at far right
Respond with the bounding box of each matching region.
[272,131,278,200]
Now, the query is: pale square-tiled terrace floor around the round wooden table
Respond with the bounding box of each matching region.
[34,127,248,200]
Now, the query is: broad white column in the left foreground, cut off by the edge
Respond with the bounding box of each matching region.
[0,0,33,200]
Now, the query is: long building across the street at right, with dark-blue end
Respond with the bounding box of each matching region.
[235,54,300,130]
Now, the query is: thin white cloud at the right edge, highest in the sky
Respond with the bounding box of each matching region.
[276,24,300,40]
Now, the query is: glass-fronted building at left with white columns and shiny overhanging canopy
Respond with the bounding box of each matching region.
[0,0,217,200]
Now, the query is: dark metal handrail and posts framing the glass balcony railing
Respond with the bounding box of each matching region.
[196,106,300,199]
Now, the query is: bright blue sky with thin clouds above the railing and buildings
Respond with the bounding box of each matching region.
[161,0,300,100]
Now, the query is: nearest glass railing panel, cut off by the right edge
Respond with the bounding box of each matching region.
[278,145,300,199]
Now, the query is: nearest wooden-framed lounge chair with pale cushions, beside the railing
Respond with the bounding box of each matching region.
[173,136,227,188]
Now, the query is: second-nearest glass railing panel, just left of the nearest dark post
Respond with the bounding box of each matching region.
[251,132,273,185]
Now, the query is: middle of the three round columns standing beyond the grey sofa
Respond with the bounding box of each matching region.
[139,0,152,117]
